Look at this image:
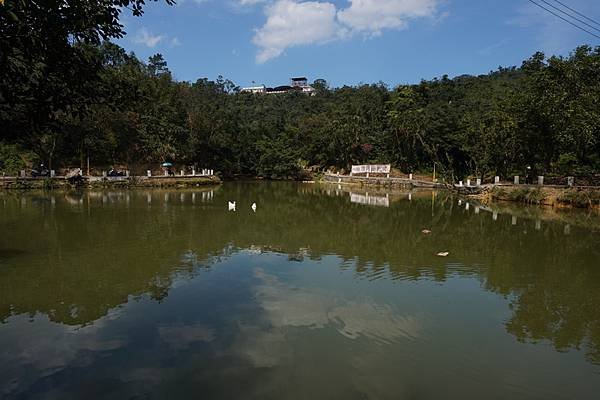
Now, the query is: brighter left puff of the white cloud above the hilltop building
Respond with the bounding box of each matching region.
[253,0,339,63]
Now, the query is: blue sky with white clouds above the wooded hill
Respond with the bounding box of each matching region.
[118,0,600,86]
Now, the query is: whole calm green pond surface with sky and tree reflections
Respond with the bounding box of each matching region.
[0,183,600,400]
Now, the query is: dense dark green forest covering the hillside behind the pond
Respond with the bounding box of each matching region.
[0,0,600,179]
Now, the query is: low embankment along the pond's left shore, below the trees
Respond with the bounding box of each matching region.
[0,176,221,190]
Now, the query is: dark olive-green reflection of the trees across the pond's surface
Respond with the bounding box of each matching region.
[0,183,600,362]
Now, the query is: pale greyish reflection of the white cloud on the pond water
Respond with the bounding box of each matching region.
[256,270,421,343]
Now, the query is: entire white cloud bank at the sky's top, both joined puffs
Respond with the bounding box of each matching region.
[251,0,442,63]
